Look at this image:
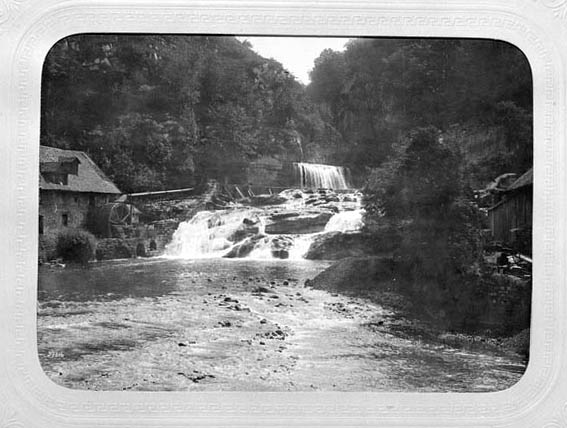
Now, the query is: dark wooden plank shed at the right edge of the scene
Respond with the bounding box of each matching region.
[488,168,533,254]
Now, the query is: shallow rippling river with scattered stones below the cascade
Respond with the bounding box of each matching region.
[38,259,525,392]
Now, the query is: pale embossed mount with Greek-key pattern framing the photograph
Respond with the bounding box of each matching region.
[0,0,567,428]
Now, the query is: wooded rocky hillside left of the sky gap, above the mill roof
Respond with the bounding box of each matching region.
[41,35,340,192]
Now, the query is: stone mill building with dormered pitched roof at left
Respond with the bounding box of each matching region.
[39,146,120,256]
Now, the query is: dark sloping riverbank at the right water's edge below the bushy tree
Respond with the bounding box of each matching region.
[307,256,529,362]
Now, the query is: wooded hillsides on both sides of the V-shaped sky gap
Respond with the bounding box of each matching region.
[41,35,532,192]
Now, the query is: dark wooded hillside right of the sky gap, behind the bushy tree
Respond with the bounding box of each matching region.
[307,38,532,186]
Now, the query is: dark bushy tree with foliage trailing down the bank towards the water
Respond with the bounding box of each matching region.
[367,127,500,330]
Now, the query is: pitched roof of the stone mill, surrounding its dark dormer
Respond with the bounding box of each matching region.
[39,146,121,194]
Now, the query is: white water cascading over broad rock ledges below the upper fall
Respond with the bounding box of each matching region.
[165,189,363,260]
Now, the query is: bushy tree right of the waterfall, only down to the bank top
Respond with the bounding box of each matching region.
[366,127,481,282]
